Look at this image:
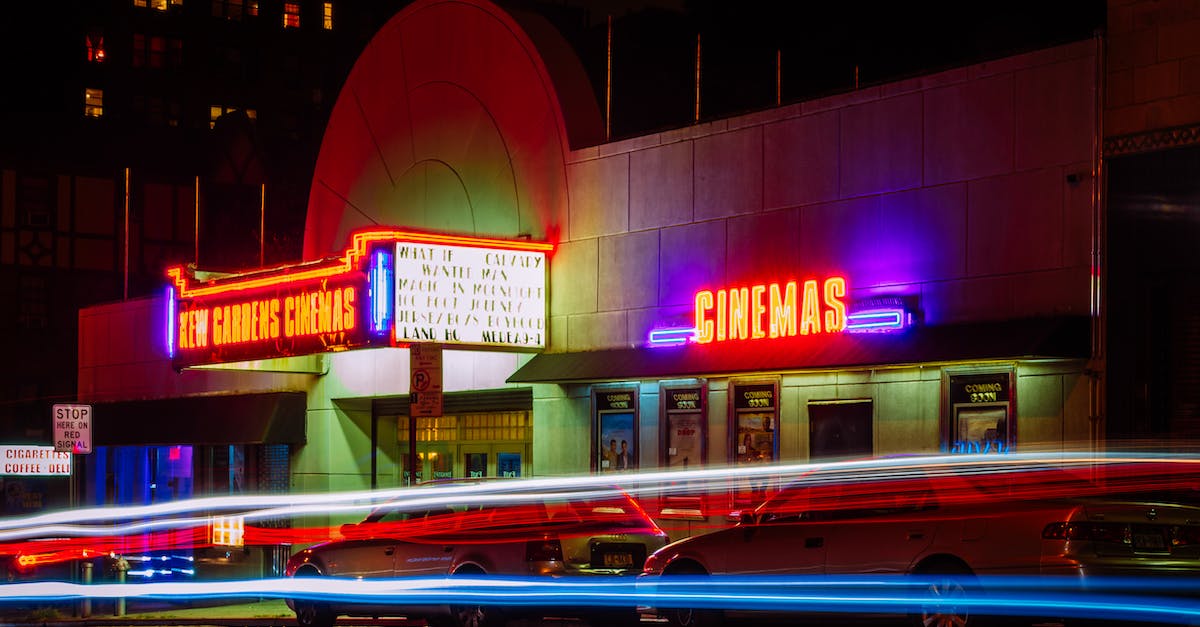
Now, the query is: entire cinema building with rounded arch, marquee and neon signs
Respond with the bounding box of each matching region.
[79,0,1104,574]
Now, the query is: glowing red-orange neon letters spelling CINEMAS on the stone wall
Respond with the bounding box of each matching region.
[695,276,846,344]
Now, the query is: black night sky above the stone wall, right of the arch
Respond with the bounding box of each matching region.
[530,0,1105,137]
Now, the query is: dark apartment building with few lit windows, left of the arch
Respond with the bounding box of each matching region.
[0,0,402,458]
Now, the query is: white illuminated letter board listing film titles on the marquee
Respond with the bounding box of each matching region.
[396,241,546,350]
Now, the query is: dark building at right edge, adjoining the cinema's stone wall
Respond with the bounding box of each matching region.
[1102,0,1200,444]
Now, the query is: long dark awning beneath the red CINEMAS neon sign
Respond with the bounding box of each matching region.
[509,316,1091,383]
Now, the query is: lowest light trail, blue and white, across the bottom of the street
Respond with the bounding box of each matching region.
[0,575,1200,623]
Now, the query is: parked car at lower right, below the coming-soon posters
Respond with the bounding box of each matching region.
[640,454,1200,627]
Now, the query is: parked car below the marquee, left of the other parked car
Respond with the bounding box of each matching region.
[286,480,667,627]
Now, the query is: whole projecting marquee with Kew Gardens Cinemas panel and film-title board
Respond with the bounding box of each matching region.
[167,229,553,369]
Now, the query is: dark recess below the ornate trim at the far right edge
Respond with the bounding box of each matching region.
[1105,148,1200,440]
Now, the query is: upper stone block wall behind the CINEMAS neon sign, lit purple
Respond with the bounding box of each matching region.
[550,41,1098,352]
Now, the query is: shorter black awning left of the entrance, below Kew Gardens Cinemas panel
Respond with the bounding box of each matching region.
[92,392,308,446]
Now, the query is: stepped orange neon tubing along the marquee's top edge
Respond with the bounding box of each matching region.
[167,228,554,299]
